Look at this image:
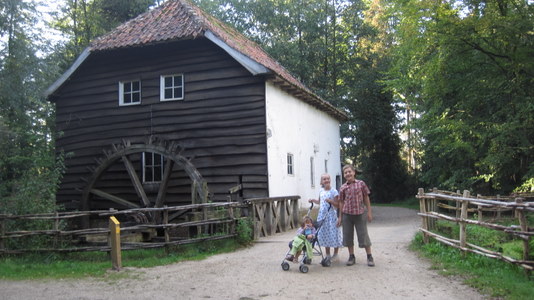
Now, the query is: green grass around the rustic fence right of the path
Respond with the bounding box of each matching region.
[384,197,534,300]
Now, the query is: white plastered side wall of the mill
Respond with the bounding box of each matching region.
[266,82,341,208]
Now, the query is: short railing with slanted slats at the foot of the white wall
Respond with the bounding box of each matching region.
[244,196,300,239]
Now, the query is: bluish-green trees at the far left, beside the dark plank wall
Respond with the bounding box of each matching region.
[0,0,61,221]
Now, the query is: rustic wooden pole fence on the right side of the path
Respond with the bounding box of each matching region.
[417,189,534,270]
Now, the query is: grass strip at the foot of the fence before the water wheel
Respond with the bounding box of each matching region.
[0,239,242,280]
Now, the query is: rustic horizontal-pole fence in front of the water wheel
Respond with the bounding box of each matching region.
[0,202,242,254]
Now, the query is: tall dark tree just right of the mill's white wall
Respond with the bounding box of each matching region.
[341,1,414,202]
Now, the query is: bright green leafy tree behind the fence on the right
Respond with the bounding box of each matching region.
[388,0,534,193]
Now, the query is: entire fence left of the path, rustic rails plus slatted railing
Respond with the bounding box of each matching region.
[0,196,300,254]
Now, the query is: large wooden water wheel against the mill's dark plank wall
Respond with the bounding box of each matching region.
[81,137,208,217]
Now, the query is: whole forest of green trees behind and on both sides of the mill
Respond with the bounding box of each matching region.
[0,0,534,214]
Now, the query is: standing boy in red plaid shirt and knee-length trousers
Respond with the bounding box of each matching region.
[337,165,375,267]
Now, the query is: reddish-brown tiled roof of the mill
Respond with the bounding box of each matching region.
[89,0,346,120]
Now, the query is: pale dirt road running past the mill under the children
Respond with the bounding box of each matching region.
[0,207,490,300]
